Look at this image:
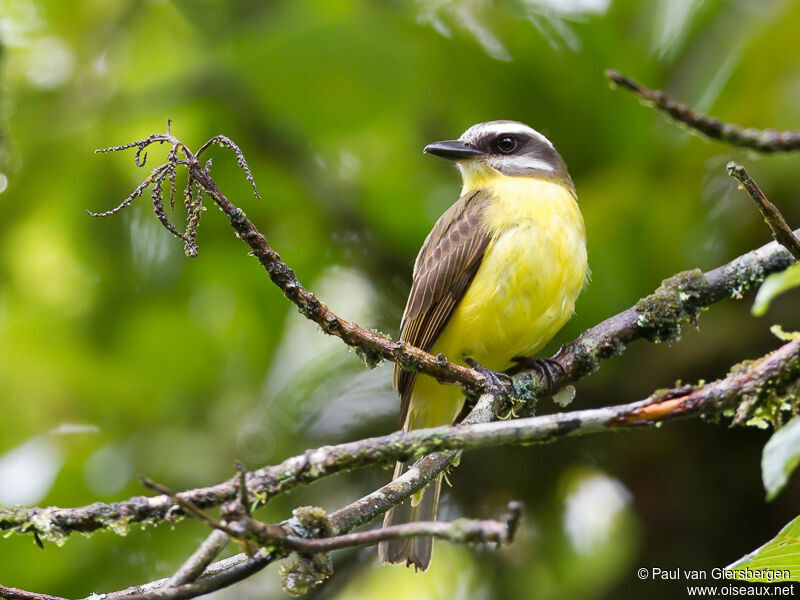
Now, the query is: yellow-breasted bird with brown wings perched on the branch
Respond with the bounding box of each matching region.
[378,120,589,571]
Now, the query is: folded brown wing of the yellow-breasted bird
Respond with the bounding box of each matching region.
[394,191,489,427]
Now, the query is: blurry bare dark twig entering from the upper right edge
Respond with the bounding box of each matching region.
[606,69,800,153]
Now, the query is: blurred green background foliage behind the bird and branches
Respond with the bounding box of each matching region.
[0,0,800,599]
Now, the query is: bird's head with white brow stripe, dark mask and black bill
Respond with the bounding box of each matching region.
[424,121,572,195]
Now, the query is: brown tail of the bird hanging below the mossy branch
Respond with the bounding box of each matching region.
[378,462,442,571]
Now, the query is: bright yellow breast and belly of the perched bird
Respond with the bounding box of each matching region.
[434,176,587,370]
